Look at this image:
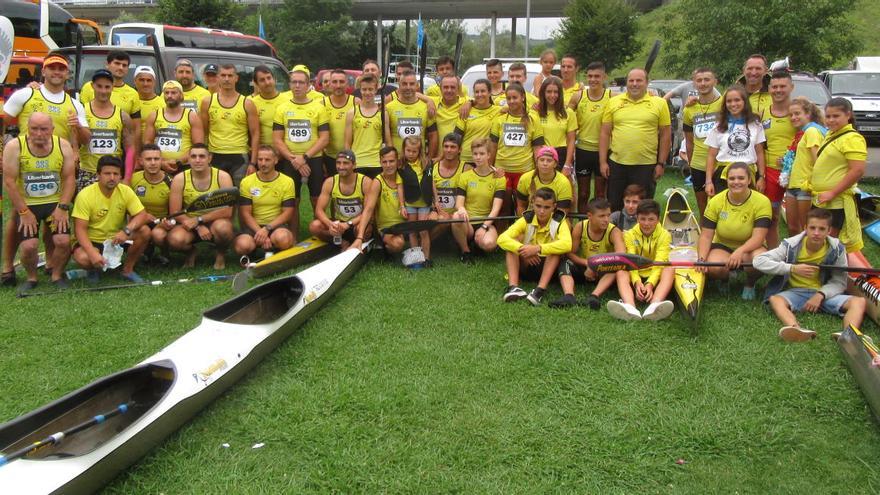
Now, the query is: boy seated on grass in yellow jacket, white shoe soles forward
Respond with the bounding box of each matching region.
[607,199,675,321]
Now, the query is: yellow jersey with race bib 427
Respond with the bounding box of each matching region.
[490,112,544,173]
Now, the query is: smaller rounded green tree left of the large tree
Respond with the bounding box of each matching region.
[556,0,638,71]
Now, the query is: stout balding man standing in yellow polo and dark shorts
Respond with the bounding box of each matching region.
[599,69,672,210]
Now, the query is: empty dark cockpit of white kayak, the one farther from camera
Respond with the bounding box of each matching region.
[204,276,303,325]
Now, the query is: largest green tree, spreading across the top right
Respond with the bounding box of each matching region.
[660,0,861,82]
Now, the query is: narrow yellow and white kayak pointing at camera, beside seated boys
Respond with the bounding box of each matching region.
[663,188,706,332]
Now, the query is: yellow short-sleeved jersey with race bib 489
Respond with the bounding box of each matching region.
[272,99,330,154]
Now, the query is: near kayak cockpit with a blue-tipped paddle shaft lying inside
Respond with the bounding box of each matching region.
[0,361,176,469]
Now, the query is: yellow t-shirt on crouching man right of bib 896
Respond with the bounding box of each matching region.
[72,183,144,243]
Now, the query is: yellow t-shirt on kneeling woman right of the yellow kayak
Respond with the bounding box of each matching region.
[702,191,773,250]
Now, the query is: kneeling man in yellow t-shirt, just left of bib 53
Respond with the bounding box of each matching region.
[233,144,296,256]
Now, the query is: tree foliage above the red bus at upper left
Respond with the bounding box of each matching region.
[156,0,244,29]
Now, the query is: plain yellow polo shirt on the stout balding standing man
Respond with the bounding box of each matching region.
[602,93,671,165]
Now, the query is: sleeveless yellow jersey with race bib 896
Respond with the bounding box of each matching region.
[18,136,64,206]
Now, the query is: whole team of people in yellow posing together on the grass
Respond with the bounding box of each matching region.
[2,51,866,340]
